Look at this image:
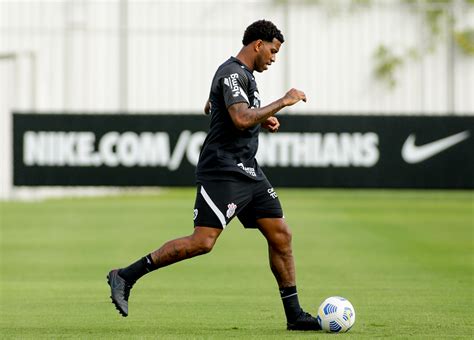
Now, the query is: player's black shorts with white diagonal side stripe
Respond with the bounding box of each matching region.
[194,178,283,228]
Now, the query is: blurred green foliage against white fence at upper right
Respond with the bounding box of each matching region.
[275,0,474,89]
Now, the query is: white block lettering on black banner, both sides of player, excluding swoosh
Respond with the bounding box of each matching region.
[23,130,380,171]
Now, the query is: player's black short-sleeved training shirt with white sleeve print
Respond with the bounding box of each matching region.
[196,57,265,180]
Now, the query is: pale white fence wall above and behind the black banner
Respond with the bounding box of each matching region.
[0,0,474,114]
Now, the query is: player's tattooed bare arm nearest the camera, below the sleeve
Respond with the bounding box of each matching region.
[227,89,306,130]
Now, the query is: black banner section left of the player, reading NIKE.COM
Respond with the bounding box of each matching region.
[13,114,209,186]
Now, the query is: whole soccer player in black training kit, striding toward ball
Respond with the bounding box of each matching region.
[107,20,321,330]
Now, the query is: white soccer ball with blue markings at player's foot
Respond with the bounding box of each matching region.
[317,296,355,333]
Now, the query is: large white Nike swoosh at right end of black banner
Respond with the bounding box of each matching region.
[402,131,469,164]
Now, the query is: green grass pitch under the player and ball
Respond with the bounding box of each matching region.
[0,189,474,339]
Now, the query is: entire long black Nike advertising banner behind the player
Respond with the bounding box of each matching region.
[13,113,474,189]
